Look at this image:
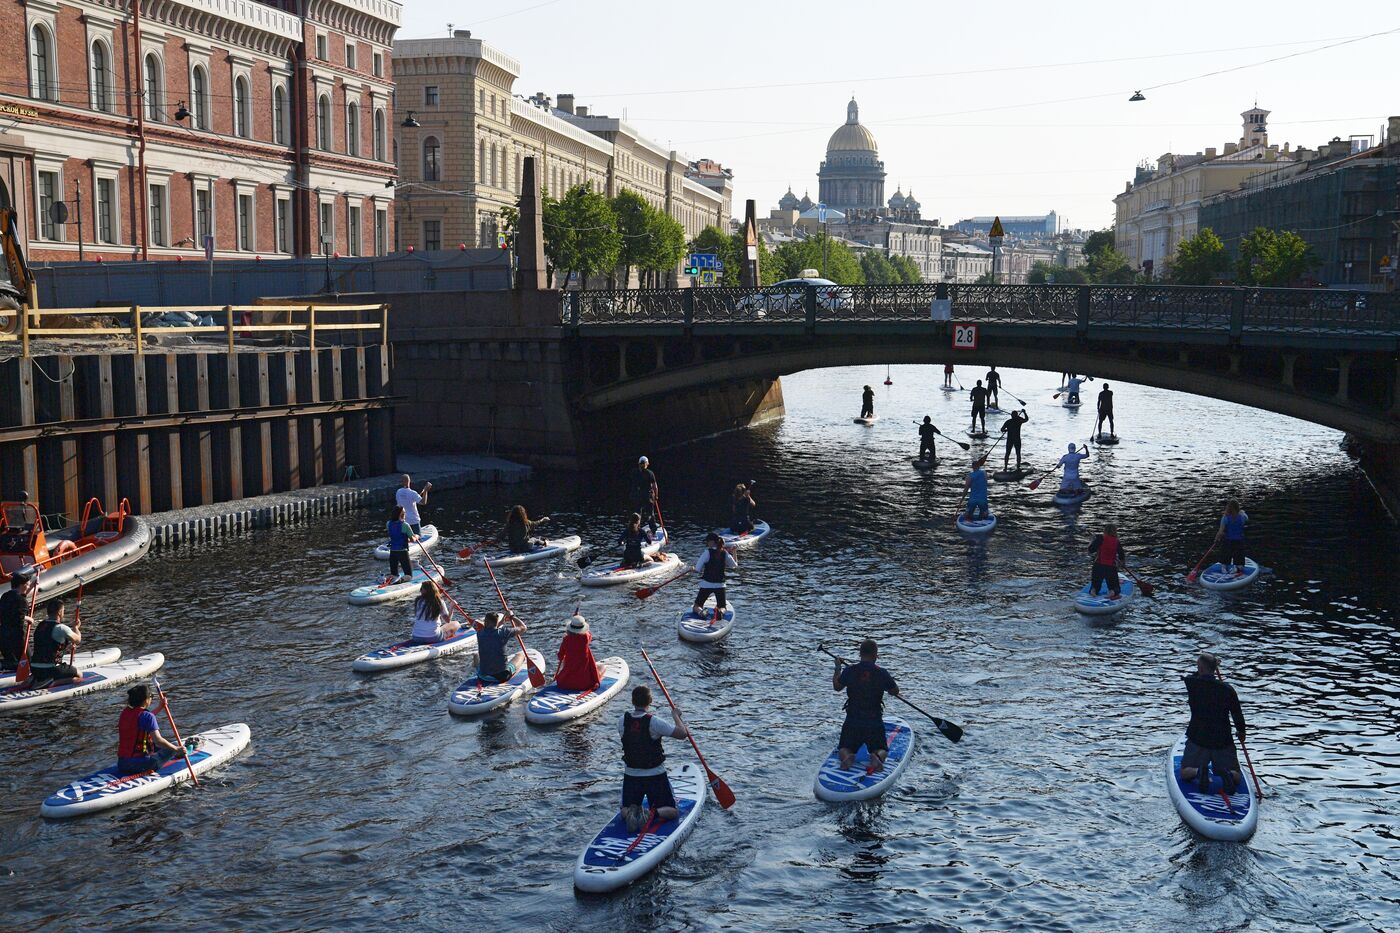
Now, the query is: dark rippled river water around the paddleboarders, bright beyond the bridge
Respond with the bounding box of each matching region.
[0,367,1400,932]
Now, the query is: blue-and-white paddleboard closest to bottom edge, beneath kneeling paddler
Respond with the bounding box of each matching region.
[574,762,706,894]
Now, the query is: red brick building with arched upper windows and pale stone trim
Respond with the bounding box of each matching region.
[0,0,400,261]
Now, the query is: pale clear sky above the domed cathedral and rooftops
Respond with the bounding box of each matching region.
[399,0,1400,228]
